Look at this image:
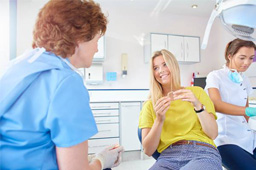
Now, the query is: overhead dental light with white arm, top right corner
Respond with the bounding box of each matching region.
[201,0,256,49]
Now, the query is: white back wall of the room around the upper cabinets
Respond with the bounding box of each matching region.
[5,0,253,89]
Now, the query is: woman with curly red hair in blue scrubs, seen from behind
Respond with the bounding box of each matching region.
[0,0,123,170]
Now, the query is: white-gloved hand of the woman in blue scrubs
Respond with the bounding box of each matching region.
[94,145,124,169]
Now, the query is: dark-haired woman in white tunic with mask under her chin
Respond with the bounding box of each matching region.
[205,39,256,170]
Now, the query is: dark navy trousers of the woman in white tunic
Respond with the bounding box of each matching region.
[218,144,256,170]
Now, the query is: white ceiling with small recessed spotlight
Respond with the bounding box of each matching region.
[95,0,216,17]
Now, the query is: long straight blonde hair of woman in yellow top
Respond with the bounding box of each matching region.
[148,49,181,105]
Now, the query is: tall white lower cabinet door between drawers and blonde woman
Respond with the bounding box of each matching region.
[120,102,140,151]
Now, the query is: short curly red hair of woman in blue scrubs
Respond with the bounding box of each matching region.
[32,0,107,58]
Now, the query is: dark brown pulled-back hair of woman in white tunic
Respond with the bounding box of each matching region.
[225,38,256,64]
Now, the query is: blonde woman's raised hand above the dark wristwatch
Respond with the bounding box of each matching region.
[173,89,202,110]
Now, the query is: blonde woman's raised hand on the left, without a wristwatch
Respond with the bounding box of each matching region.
[154,96,171,122]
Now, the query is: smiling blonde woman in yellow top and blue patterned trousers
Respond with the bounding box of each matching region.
[139,50,222,170]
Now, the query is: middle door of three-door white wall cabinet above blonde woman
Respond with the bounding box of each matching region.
[168,35,184,61]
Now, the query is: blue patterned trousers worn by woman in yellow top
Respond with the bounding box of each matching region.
[150,142,222,170]
